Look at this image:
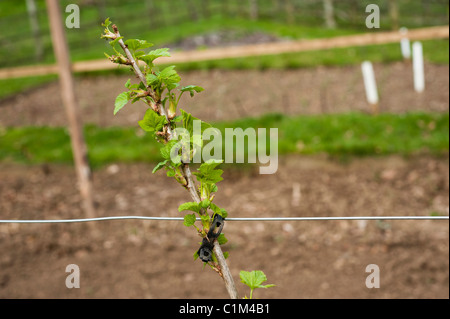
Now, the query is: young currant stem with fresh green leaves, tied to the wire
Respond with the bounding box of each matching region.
[102,18,274,296]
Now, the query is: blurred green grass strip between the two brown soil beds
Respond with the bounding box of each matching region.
[0,113,449,167]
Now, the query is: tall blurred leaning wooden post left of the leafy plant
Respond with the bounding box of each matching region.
[46,0,95,218]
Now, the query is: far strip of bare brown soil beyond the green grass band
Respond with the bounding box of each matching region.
[0,63,449,127]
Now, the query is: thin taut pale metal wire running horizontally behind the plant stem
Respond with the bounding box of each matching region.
[0,216,449,224]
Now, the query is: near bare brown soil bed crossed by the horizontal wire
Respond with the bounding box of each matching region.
[0,155,449,298]
